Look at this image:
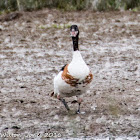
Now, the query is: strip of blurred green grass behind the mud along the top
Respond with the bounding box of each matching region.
[0,0,140,11]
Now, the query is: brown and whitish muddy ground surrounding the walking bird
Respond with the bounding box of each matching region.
[0,9,140,140]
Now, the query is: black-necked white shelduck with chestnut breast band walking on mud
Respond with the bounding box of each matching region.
[51,25,93,114]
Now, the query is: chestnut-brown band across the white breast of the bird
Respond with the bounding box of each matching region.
[62,64,93,87]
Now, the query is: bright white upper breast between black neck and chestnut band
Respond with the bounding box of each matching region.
[68,51,90,81]
